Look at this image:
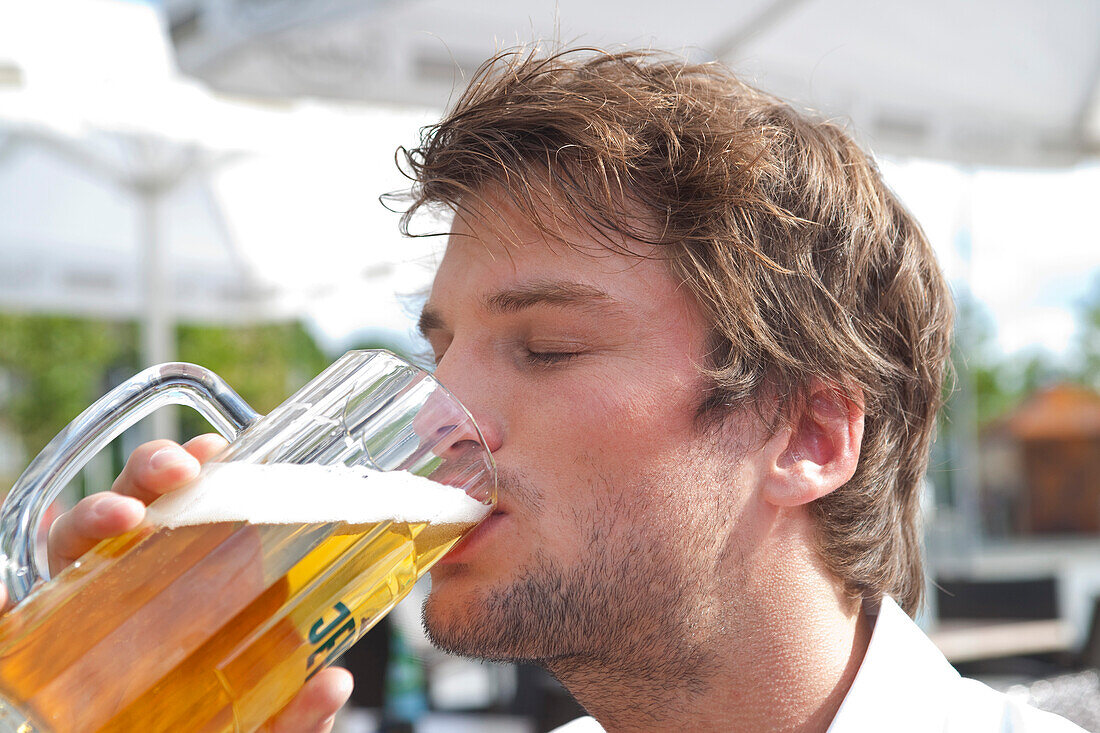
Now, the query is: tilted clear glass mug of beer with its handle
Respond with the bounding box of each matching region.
[0,351,496,733]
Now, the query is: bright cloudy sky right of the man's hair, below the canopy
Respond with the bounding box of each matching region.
[882,161,1100,359]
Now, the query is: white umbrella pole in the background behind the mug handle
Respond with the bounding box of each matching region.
[138,186,178,440]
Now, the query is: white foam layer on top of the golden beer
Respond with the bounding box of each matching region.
[146,462,490,527]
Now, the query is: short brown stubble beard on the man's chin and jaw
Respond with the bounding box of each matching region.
[415,464,714,712]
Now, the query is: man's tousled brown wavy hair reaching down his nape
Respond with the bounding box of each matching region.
[398,48,953,613]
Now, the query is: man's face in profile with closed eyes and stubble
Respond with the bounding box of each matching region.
[421,191,756,665]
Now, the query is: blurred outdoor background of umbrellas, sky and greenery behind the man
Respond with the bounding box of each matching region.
[0,0,1100,733]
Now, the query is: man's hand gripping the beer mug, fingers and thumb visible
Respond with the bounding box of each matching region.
[0,435,352,733]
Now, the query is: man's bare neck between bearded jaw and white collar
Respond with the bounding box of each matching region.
[550,593,872,733]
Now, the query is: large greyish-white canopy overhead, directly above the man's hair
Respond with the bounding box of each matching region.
[165,0,1100,166]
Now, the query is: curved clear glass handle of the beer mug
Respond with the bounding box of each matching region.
[0,362,260,603]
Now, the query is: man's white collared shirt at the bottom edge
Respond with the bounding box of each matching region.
[553,598,1084,733]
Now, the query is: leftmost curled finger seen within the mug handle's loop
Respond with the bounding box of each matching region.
[46,491,145,575]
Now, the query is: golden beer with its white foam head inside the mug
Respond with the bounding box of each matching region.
[0,463,488,733]
